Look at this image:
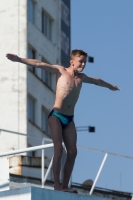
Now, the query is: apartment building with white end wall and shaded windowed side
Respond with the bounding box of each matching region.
[0,0,70,180]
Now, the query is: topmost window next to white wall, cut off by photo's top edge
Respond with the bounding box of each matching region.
[28,0,35,24]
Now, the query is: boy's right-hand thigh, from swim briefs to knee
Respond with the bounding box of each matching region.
[62,121,77,149]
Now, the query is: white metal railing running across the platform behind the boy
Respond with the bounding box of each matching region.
[0,129,133,195]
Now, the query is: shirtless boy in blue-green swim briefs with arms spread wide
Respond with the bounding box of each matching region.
[6,50,120,193]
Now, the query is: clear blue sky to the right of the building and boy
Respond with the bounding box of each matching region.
[71,0,133,192]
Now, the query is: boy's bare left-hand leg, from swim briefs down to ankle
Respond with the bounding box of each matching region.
[48,116,63,190]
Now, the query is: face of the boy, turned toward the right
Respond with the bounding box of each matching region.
[70,55,86,72]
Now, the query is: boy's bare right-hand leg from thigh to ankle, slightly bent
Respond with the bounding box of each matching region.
[62,121,77,189]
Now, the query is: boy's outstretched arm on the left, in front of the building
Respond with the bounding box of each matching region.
[6,53,61,73]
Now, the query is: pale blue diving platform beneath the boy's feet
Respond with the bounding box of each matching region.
[0,186,109,200]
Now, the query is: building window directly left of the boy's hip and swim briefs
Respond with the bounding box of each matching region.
[42,108,50,135]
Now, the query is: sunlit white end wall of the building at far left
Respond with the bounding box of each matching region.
[0,0,27,151]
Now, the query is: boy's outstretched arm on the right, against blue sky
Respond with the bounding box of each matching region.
[83,74,120,90]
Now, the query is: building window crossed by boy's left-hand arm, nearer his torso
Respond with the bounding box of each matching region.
[42,58,52,88]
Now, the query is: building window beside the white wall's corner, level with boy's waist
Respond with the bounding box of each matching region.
[28,96,35,124]
